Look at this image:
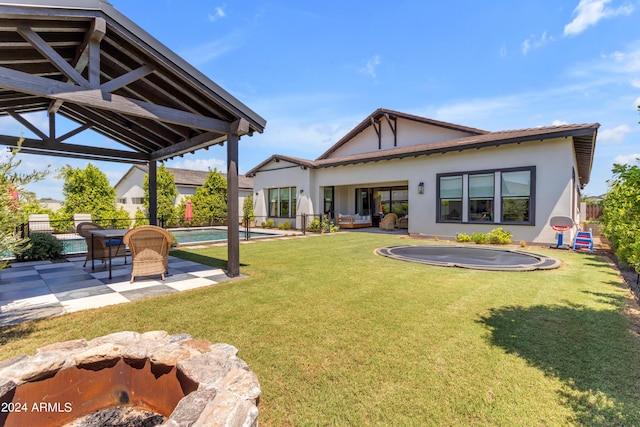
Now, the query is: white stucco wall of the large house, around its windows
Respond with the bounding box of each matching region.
[255,138,577,244]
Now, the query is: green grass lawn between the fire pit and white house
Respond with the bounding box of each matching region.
[0,233,640,426]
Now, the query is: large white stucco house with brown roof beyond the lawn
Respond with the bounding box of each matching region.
[247,109,600,243]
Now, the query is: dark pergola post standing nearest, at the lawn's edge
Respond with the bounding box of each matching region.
[227,134,240,277]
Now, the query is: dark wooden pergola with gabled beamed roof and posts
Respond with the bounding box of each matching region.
[0,0,266,277]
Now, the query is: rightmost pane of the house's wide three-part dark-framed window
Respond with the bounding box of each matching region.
[501,170,531,223]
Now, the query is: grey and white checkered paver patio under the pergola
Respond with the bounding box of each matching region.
[0,256,242,326]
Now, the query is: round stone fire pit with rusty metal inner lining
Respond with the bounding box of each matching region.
[0,331,260,427]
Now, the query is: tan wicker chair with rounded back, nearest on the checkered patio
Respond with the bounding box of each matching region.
[124,225,172,283]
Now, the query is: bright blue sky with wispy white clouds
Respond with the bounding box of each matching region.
[5,0,640,198]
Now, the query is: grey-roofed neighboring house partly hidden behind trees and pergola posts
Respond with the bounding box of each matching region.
[114,165,253,218]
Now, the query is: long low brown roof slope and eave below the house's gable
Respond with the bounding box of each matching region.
[247,115,600,186]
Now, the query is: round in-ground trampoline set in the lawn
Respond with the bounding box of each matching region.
[376,245,561,271]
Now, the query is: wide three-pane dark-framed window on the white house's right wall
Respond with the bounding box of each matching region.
[437,167,535,225]
